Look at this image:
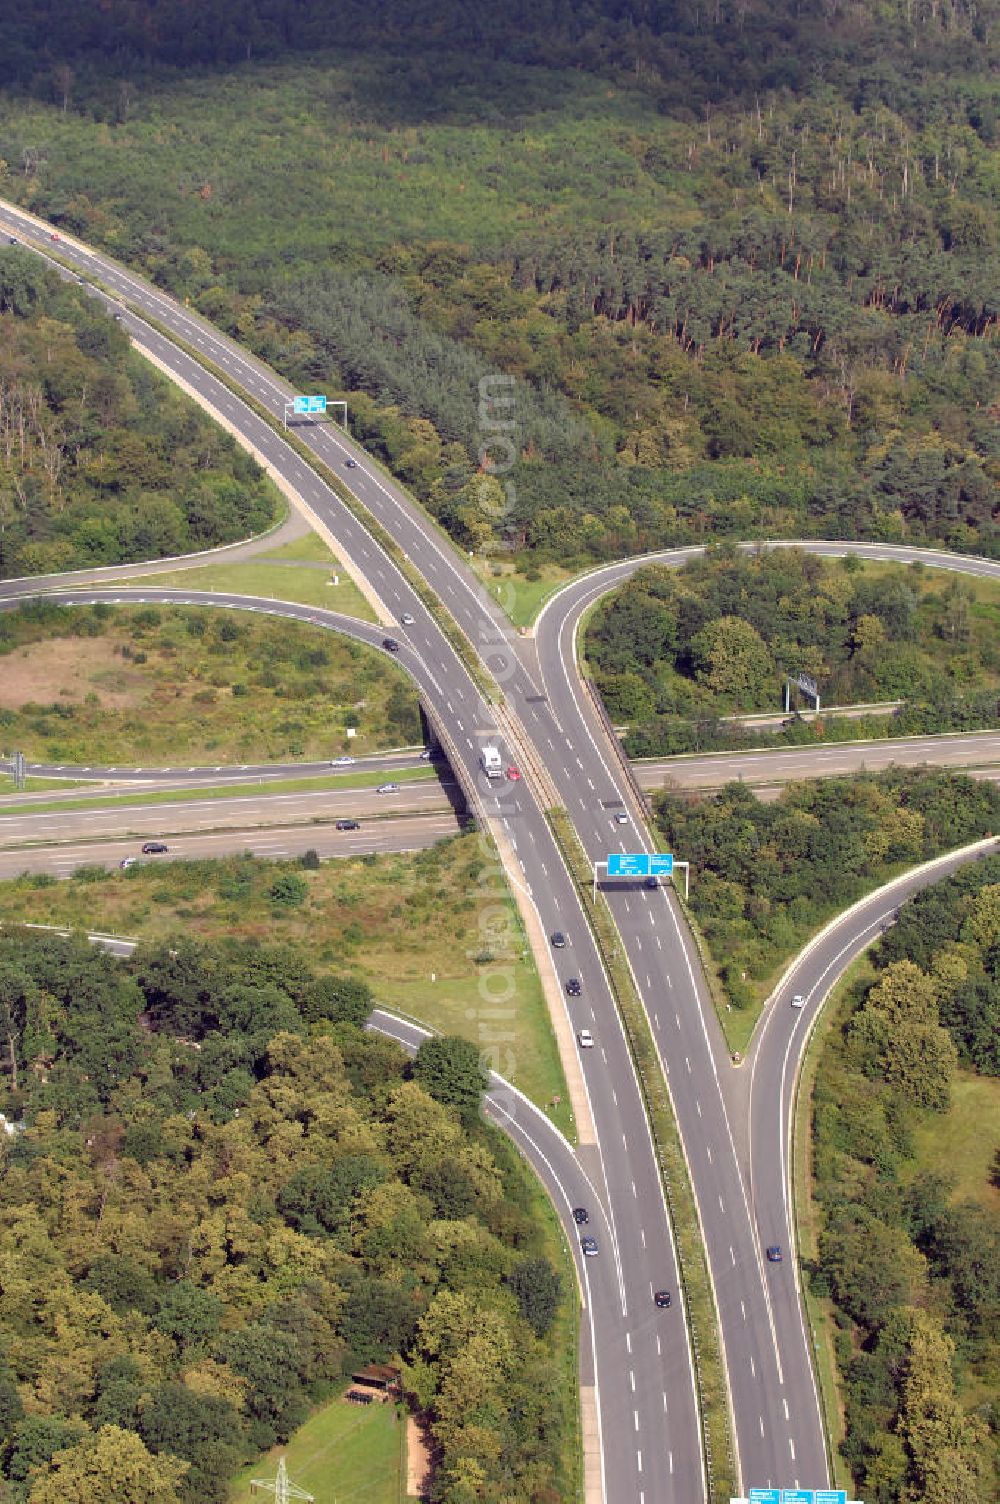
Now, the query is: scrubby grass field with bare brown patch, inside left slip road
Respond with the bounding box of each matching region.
[0,601,420,766]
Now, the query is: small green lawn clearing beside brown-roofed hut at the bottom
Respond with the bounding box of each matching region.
[229,1396,406,1504]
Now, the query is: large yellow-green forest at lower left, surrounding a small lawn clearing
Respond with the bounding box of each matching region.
[0,929,571,1504]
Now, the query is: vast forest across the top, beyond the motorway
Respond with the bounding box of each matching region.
[0,0,1000,569]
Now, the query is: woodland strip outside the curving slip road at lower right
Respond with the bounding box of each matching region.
[808,857,1000,1504]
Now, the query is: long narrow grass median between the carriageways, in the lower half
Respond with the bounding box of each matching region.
[549,809,735,1504]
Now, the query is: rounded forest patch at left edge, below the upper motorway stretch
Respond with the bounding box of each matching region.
[0,245,278,578]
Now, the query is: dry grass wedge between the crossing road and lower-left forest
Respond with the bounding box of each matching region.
[0,833,573,1134]
